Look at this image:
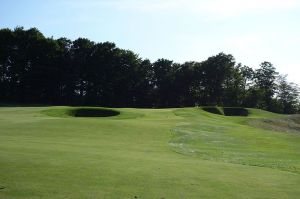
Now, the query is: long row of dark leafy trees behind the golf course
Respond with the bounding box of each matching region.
[0,27,300,113]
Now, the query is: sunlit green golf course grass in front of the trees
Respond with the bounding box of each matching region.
[0,107,300,199]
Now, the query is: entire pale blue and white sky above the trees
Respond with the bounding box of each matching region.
[0,0,300,84]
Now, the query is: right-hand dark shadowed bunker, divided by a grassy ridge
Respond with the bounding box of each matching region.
[202,107,249,116]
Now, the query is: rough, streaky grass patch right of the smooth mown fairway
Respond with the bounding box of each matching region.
[170,109,300,174]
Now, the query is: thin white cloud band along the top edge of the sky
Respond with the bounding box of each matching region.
[102,0,299,19]
